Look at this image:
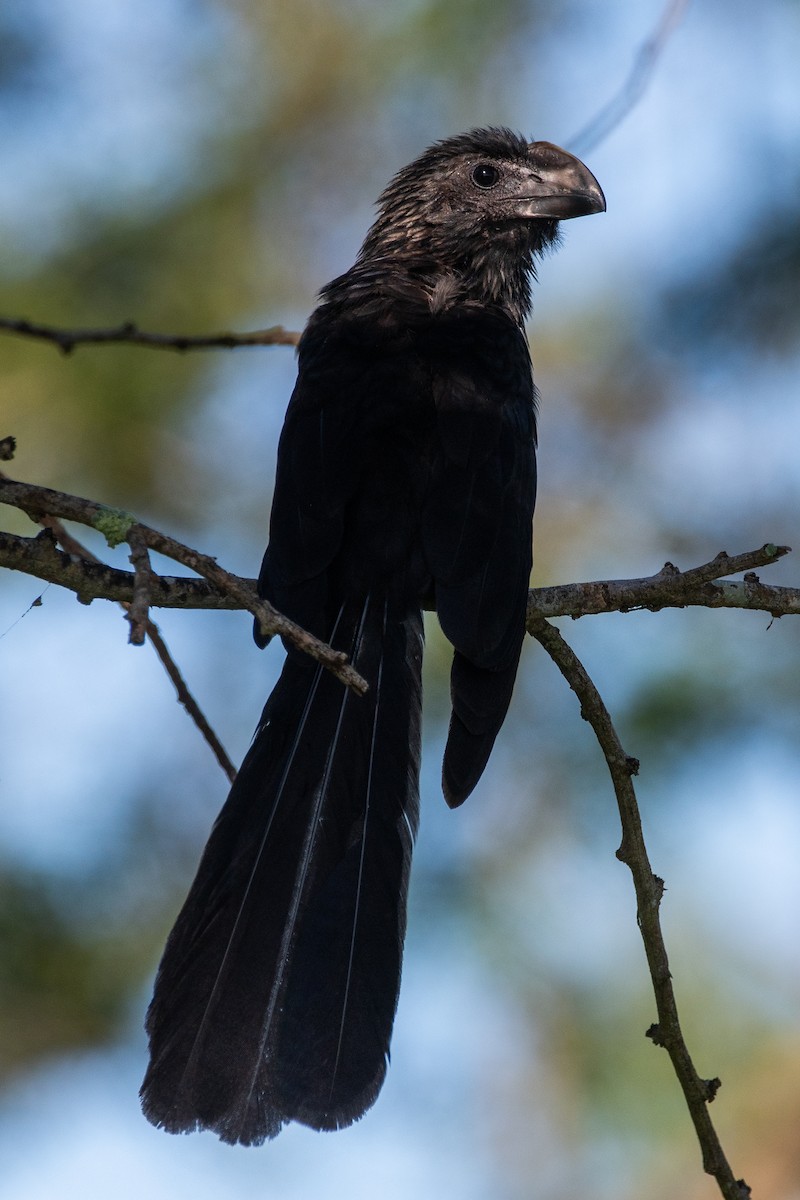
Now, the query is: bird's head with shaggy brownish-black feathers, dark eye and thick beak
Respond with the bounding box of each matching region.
[360,128,606,316]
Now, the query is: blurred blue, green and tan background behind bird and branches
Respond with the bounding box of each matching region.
[0,0,800,1200]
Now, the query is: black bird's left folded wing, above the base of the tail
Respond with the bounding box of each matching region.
[259,292,437,636]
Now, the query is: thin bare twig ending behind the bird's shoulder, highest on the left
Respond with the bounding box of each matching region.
[0,317,300,354]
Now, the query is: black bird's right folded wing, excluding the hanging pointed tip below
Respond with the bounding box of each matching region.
[422,310,536,670]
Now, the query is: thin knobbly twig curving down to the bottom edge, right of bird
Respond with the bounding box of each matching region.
[531,618,751,1200]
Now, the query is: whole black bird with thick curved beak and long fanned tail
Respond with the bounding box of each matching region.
[142,128,606,1145]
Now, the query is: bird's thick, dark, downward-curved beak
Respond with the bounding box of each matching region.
[517,142,606,221]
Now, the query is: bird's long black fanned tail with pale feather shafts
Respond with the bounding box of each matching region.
[142,596,422,1144]
